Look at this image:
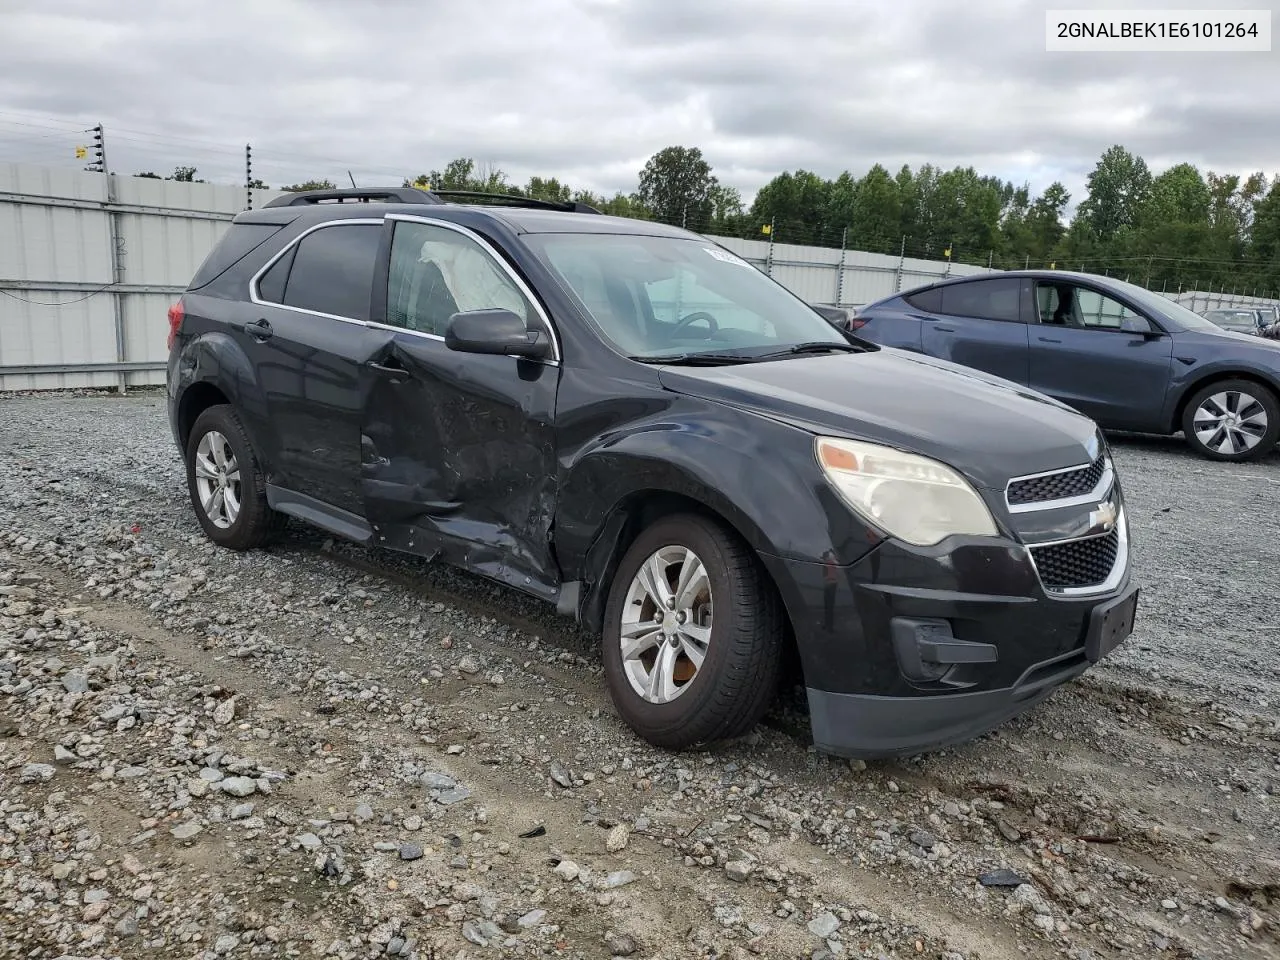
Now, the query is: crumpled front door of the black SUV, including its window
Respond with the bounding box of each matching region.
[361,216,559,599]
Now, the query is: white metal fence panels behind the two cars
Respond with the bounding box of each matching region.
[0,164,1280,390]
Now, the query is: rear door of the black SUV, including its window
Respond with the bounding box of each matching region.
[247,218,385,513]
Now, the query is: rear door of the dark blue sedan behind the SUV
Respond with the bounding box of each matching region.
[918,276,1030,385]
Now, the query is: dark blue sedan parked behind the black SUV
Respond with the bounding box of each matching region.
[849,270,1280,461]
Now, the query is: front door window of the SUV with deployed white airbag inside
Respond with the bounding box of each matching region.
[387,220,538,337]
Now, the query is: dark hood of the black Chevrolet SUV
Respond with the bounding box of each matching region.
[659,348,1100,490]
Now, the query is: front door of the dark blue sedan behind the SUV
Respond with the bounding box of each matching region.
[1030,280,1174,433]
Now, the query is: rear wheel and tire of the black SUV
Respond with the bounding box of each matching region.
[187,403,288,550]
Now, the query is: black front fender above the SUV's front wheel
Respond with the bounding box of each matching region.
[556,399,881,630]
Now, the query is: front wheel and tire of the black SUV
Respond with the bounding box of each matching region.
[603,515,785,750]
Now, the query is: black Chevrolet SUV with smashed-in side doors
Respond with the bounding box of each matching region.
[168,189,1138,758]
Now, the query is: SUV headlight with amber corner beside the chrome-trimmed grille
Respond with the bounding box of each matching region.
[817,436,997,547]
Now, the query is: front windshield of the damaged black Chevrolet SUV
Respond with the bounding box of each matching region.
[526,233,850,360]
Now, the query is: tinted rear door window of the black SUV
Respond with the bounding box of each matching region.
[280,224,383,320]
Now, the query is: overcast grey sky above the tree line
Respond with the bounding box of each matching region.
[0,0,1280,205]
